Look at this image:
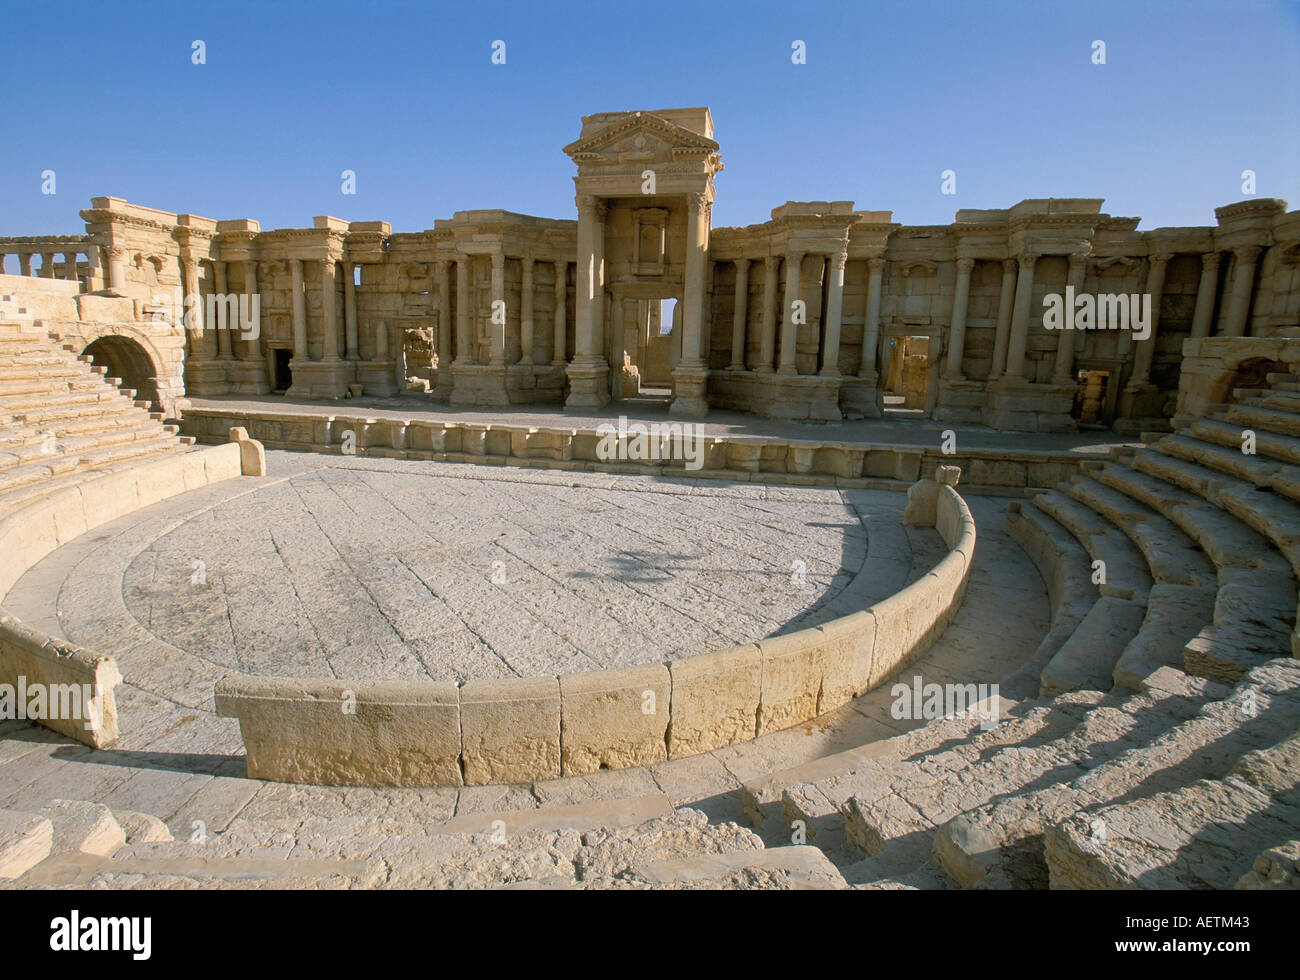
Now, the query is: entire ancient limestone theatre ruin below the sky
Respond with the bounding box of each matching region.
[0,103,1300,890]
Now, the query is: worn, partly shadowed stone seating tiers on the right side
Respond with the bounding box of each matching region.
[748,376,1300,888]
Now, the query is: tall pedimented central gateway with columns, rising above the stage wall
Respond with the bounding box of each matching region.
[564,108,723,416]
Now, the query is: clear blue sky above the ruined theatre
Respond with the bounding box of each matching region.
[0,0,1300,235]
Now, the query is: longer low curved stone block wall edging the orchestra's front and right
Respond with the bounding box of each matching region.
[216,481,975,785]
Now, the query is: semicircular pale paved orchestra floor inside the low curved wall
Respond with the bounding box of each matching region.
[111,452,866,681]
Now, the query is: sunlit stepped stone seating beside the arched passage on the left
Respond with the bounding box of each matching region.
[0,322,194,513]
